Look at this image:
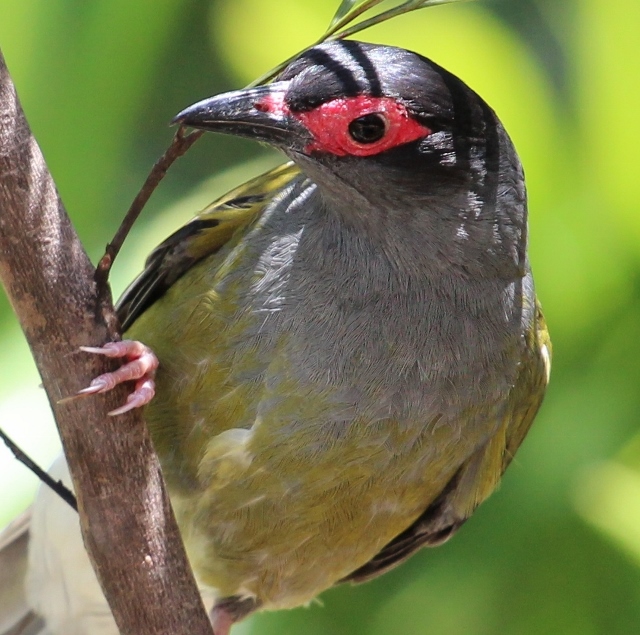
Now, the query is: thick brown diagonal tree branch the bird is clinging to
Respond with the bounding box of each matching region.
[0,48,211,635]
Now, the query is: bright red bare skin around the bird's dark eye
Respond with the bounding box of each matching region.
[255,95,431,157]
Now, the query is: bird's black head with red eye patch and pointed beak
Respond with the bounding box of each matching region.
[174,41,526,278]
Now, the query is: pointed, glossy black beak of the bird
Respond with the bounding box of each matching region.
[171,82,311,150]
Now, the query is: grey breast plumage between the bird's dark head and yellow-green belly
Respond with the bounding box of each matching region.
[228,171,534,419]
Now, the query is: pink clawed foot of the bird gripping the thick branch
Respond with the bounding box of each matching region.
[77,340,158,417]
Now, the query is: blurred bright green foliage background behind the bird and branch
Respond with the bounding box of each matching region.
[0,0,640,635]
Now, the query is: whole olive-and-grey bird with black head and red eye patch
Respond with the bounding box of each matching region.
[0,40,551,635]
